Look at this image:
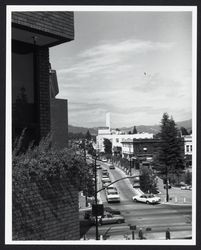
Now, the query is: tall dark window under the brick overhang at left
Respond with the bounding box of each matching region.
[12,42,39,146]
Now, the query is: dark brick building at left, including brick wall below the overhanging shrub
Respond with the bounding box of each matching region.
[12,12,80,240]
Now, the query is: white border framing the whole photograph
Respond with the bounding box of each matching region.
[5,5,197,246]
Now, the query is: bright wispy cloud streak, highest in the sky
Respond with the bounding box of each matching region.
[57,39,174,78]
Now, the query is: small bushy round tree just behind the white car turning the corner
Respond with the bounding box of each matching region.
[140,166,157,193]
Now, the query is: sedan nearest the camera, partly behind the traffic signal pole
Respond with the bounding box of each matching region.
[89,213,125,225]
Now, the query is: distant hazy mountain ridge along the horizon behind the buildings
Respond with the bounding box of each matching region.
[68,119,192,135]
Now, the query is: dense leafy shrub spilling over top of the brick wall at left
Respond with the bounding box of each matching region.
[13,134,93,190]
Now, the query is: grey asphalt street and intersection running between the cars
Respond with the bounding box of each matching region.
[82,164,192,239]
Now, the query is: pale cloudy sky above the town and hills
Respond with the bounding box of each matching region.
[50,11,192,128]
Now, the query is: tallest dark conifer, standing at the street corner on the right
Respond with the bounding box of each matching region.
[158,113,184,202]
